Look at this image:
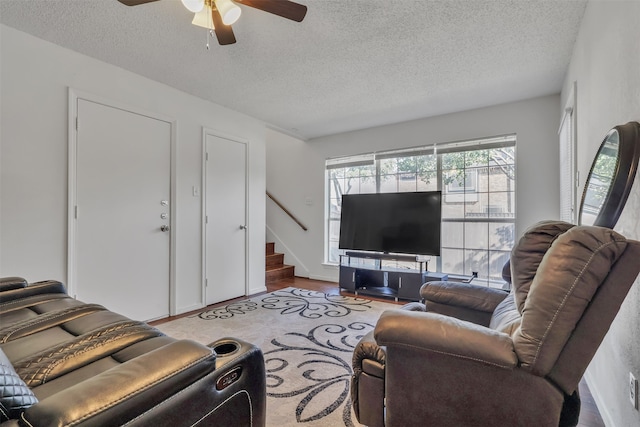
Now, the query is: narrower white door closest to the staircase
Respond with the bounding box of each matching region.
[205,133,248,305]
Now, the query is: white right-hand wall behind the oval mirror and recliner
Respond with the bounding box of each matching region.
[562,1,640,427]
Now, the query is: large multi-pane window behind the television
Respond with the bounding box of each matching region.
[325,135,516,281]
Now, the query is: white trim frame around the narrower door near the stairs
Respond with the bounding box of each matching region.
[200,126,252,307]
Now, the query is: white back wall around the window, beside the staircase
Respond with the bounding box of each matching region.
[266,95,560,281]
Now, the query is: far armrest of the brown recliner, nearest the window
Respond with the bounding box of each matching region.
[420,281,509,326]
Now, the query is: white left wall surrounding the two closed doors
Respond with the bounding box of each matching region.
[0,25,265,312]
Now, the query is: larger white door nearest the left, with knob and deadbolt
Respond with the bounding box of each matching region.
[75,98,171,320]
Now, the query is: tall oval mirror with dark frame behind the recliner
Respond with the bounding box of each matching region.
[578,122,640,228]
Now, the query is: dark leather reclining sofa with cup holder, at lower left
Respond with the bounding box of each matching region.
[0,278,266,427]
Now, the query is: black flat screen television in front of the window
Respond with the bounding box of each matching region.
[338,191,442,256]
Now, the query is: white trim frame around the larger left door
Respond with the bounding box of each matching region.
[66,87,177,315]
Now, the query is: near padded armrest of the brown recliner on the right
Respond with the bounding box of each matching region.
[374,310,518,369]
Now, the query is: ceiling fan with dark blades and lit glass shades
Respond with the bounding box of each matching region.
[118,0,307,45]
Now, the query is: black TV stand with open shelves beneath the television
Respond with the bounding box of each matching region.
[339,251,448,301]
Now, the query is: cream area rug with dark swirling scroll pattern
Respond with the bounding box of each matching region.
[157,288,399,427]
